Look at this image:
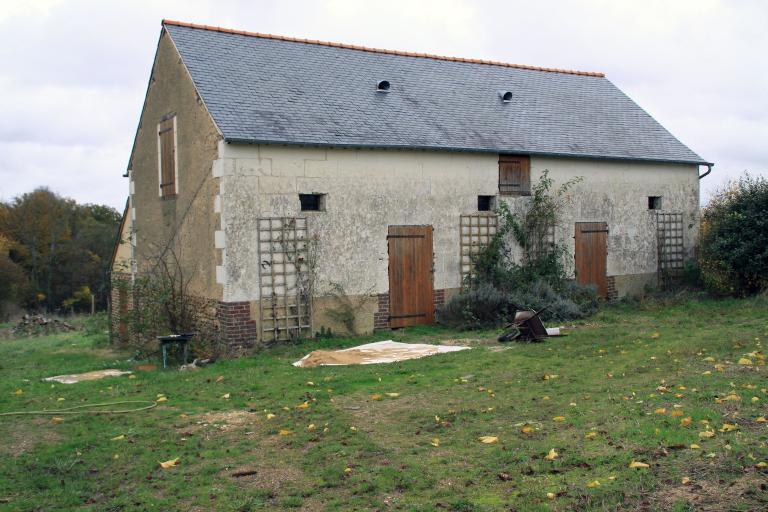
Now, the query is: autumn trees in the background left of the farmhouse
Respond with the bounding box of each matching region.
[0,188,121,318]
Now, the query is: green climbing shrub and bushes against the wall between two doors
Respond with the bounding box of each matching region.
[438,171,598,329]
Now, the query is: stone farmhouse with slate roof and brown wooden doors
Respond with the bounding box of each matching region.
[112,21,712,349]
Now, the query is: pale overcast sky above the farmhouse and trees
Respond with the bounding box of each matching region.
[0,0,768,209]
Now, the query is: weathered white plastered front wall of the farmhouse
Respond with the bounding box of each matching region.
[213,143,698,302]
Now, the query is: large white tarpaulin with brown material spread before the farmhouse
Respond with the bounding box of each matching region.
[293,340,470,368]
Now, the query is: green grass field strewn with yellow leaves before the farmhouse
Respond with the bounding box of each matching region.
[0,298,768,511]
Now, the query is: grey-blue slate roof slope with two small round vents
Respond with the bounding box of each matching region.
[163,21,707,164]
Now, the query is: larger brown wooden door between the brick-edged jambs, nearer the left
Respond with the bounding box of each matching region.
[387,226,435,327]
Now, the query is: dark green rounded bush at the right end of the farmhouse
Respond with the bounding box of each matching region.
[700,174,768,296]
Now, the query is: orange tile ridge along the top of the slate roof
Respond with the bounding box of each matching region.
[162,19,605,78]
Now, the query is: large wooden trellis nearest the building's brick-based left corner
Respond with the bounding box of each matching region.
[258,217,312,343]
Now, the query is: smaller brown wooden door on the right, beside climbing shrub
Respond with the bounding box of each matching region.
[574,222,608,297]
